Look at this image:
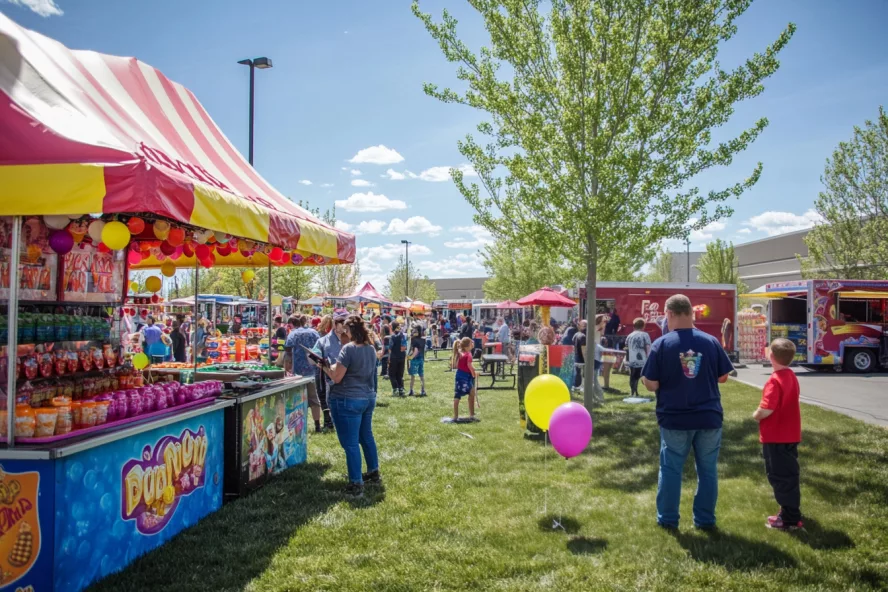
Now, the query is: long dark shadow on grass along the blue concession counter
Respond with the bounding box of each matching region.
[90,462,340,592]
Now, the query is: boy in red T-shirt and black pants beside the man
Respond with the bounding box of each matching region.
[752,339,804,530]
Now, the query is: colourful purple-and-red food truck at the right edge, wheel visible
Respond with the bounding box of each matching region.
[744,280,888,373]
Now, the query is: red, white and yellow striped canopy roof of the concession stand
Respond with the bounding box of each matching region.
[0,14,355,267]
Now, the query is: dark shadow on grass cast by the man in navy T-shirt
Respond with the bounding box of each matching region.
[670,530,796,571]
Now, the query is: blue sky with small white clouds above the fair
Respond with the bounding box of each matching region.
[0,0,888,288]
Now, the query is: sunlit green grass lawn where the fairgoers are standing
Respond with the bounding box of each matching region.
[94,362,888,592]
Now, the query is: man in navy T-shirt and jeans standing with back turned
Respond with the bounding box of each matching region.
[641,294,734,530]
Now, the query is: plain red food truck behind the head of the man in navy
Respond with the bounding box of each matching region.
[577,282,737,354]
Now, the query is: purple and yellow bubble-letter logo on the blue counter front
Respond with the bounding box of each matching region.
[121,426,207,534]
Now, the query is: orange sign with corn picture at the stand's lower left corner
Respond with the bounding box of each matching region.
[0,468,40,586]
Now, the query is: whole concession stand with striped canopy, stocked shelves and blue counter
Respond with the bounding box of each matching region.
[0,14,355,592]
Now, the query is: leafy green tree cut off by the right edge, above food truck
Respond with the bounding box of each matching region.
[800,107,888,279]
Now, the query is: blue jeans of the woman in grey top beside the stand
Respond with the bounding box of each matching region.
[329,397,379,483]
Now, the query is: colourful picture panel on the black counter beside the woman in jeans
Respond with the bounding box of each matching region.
[241,387,306,484]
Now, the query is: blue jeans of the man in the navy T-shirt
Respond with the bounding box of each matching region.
[657,428,721,528]
